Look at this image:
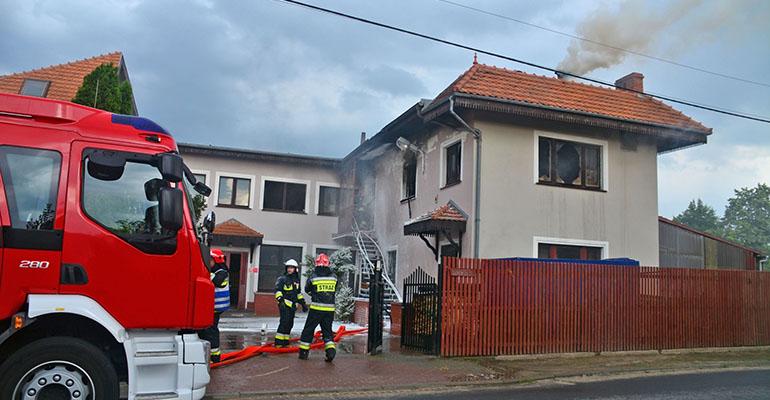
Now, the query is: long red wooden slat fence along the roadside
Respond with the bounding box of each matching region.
[441,258,770,356]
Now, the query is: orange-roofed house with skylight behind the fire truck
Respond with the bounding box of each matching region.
[0,51,138,115]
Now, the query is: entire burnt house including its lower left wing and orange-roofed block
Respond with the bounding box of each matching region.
[180,62,724,313]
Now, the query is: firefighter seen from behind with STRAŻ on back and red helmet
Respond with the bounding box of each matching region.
[299,253,337,362]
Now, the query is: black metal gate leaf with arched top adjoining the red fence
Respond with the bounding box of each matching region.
[401,267,441,354]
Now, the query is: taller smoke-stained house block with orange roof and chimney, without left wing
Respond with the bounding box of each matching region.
[335,61,712,290]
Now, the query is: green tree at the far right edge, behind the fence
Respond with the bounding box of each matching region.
[723,183,770,254]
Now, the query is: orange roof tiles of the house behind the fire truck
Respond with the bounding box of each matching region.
[0,51,123,101]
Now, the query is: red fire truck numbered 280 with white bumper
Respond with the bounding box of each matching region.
[0,94,214,400]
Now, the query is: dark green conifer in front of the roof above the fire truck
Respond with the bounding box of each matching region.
[72,64,134,114]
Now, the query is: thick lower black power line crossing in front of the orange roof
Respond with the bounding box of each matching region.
[276,0,770,124]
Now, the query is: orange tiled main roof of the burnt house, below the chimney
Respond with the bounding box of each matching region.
[436,64,711,134]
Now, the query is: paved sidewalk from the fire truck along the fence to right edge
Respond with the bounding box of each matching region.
[202,335,770,399]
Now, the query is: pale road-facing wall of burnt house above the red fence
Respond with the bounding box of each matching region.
[475,121,659,265]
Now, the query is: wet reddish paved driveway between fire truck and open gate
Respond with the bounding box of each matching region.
[207,335,495,398]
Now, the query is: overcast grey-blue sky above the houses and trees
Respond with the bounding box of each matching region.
[0,0,770,216]
